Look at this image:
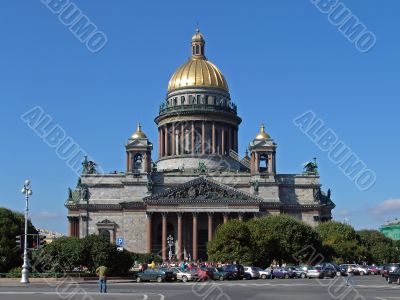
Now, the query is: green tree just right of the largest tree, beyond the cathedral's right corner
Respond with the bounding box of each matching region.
[316,221,367,263]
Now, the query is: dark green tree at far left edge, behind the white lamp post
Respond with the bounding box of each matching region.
[0,207,37,273]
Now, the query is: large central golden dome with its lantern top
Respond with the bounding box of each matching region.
[168,29,229,92]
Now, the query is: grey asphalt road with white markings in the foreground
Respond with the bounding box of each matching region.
[0,275,400,300]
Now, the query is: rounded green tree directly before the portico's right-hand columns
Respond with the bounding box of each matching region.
[207,220,254,264]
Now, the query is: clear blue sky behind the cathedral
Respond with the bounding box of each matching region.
[0,0,400,233]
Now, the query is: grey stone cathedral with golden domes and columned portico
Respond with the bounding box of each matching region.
[65,32,334,259]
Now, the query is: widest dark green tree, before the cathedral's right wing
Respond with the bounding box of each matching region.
[248,215,321,267]
